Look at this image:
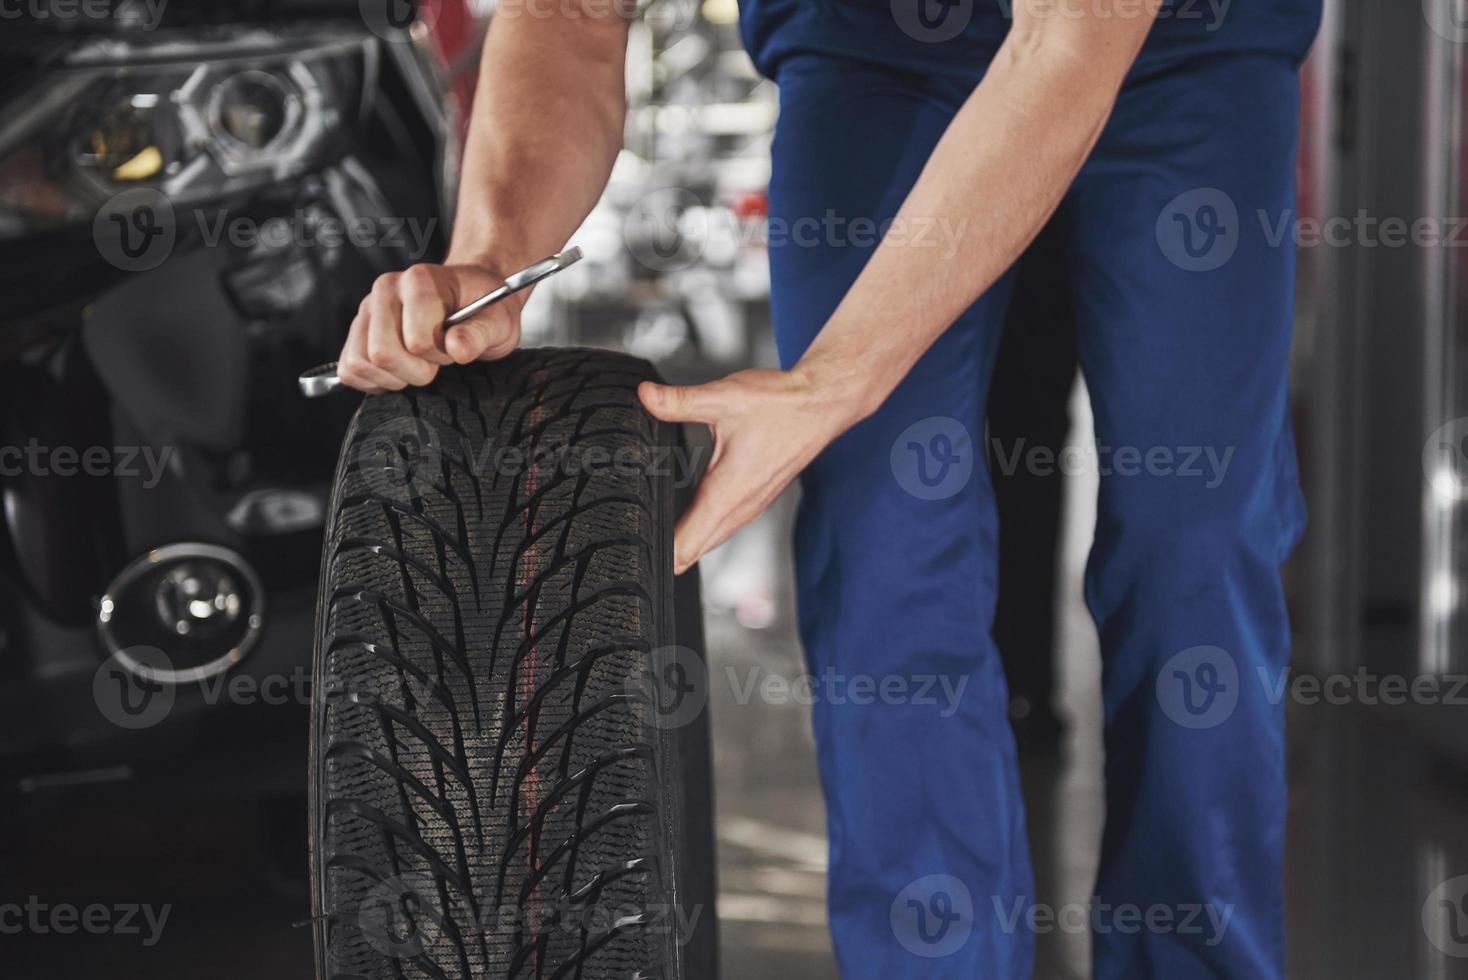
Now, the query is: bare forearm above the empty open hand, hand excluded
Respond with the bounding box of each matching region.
[797,13,1145,424]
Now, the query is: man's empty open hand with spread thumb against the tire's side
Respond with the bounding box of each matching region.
[637,368,853,575]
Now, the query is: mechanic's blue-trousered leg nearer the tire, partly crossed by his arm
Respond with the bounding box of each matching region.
[771,59,1032,980]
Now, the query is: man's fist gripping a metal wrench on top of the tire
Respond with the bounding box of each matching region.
[336,264,524,395]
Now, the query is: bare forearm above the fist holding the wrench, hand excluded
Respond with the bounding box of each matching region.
[449,0,627,274]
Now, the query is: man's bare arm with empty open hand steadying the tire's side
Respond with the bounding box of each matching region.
[642,0,1158,572]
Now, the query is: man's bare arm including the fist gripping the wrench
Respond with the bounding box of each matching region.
[338,0,630,393]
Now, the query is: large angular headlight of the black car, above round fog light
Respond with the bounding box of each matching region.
[0,31,374,238]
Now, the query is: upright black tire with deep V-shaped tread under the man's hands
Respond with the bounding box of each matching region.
[311,349,716,980]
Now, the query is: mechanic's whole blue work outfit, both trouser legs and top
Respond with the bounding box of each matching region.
[741,0,1320,980]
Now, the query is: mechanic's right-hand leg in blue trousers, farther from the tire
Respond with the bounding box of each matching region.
[1066,56,1304,980]
